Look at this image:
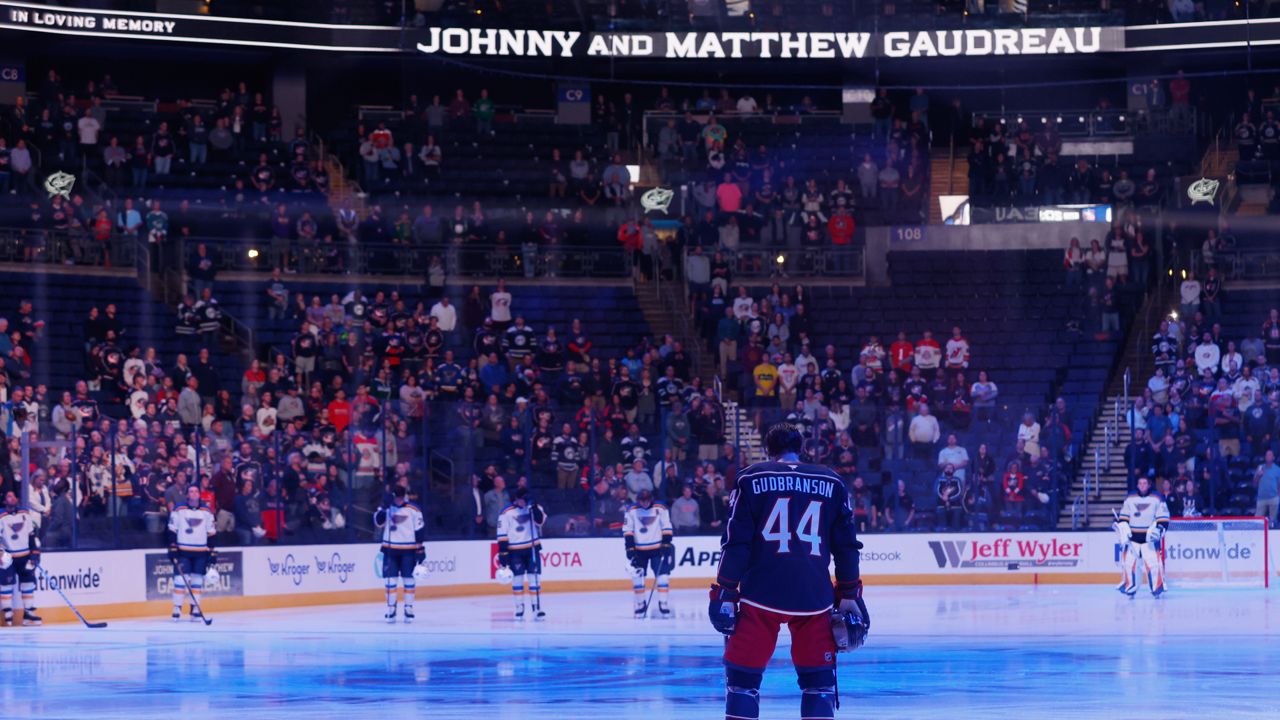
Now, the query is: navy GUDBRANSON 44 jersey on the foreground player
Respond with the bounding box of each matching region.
[717,462,861,615]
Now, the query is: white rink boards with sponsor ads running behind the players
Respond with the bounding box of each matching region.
[17,532,1280,619]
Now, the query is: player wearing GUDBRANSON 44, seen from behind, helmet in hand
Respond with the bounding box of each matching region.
[708,423,870,720]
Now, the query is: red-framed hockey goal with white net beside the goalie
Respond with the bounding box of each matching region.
[1164,518,1271,587]
